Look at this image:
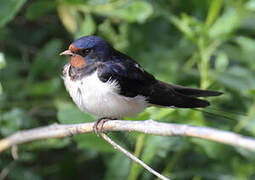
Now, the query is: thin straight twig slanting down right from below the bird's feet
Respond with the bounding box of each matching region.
[101,133,170,180]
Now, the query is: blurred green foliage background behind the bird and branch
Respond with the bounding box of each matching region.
[0,0,255,180]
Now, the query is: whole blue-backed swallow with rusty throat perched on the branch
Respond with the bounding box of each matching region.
[60,35,223,134]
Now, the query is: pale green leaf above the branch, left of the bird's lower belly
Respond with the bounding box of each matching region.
[55,101,95,124]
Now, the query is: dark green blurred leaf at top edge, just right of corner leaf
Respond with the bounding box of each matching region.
[26,0,56,20]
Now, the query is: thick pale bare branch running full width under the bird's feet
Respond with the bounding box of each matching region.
[0,120,255,152]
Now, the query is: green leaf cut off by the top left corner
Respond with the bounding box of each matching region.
[0,0,26,27]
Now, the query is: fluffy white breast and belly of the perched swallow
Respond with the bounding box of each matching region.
[64,66,147,118]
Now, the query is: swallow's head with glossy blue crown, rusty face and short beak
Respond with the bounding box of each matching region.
[60,36,111,68]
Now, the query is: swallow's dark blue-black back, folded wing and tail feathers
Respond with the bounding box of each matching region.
[98,49,222,108]
